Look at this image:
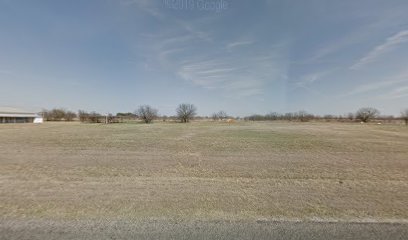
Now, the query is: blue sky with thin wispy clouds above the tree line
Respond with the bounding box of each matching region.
[0,0,408,116]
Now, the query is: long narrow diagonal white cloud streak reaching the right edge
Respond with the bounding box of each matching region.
[350,30,408,70]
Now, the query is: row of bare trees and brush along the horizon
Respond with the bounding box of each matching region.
[42,107,408,125]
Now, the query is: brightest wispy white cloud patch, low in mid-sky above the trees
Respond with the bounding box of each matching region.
[177,51,285,98]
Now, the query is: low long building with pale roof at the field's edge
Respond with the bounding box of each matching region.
[0,107,44,124]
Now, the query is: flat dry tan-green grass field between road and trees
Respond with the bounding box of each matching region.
[0,122,408,221]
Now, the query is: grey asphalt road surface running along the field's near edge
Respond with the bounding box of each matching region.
[0,220,408,240]
